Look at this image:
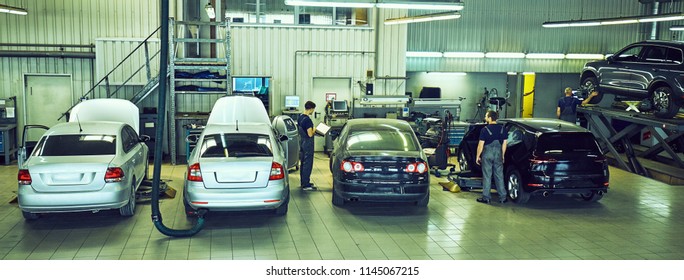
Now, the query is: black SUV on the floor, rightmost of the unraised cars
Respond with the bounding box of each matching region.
[458,119,609,203]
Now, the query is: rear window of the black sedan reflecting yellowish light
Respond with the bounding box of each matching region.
[347,130,419,151]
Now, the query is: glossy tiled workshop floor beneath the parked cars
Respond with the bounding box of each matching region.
[0,154,684,260]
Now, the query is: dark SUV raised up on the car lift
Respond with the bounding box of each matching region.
[580,41,684,118]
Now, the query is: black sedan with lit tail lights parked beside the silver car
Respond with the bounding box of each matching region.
[330,119,430,206]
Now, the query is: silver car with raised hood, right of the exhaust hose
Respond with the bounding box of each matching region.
[183,96,290,217]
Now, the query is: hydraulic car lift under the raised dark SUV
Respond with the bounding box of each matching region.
[577,106,684,177]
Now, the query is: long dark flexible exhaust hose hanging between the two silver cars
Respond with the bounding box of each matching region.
[152,0,204,237]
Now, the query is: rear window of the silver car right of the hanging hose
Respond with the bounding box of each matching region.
[200,133,273,158]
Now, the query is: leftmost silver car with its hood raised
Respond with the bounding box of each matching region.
[18,99,149,220]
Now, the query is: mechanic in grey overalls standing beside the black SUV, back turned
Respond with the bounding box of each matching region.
[476,111,508,203]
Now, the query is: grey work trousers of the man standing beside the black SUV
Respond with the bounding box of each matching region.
[482,140,506,201]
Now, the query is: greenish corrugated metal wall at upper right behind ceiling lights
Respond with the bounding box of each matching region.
[407,0,682,72]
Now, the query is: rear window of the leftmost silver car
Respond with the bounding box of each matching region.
[34,134,116,156]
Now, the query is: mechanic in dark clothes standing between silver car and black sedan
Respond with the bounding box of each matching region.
[297,101,317,191]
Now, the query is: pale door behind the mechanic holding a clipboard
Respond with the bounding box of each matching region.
[312,77,352,152]
